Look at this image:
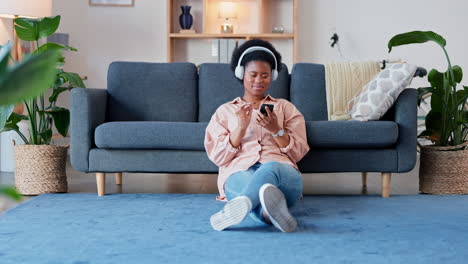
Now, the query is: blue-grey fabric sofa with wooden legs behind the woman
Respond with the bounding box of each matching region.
[70,62,417,197]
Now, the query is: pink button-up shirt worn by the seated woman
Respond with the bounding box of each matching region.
[204,95,310,200]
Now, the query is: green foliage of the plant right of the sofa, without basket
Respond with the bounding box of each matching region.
[388,31,468,146]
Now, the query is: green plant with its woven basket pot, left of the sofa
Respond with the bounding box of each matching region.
[0,16,85,195]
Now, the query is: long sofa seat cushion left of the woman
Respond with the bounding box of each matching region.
[94,121,208,151]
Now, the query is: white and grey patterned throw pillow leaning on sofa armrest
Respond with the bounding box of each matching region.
[348,63,418,121]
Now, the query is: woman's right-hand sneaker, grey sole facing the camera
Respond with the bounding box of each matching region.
[259,183,297,232]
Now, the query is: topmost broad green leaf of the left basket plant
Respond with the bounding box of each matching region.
[15,16,60,41]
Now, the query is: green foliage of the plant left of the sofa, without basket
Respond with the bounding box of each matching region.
[0,16,85,145]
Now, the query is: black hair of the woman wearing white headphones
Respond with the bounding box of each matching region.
[231,39,282,75]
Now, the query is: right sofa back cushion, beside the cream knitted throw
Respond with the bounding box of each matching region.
[290,63,328,121]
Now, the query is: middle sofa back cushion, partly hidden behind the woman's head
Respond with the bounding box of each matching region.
[198,63,290,122]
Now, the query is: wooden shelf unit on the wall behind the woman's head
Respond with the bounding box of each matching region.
[166,0,299,63]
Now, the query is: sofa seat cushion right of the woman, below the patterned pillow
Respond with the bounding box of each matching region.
[306,120,398,149]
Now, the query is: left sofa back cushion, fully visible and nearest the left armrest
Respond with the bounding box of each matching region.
[106,62,198,122]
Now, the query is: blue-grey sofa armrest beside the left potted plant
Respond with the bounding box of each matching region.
[70,88,107,172]
